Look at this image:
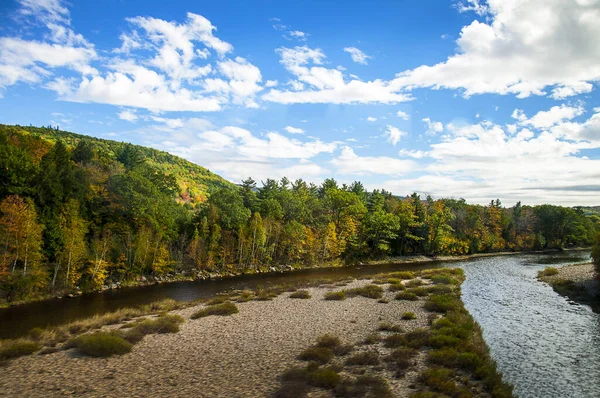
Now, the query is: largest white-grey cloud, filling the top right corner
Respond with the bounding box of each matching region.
[393,0,600,98]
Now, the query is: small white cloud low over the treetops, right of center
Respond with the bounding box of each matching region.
[330,146,414,175]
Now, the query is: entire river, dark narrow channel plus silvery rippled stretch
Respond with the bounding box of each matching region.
[0,251,600,398]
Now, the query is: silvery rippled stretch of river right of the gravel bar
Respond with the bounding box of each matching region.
[456,252,600,398]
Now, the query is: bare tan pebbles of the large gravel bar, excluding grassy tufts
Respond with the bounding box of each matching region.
[0,272,510,397]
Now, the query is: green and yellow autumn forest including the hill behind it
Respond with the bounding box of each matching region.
[0,125,600,303]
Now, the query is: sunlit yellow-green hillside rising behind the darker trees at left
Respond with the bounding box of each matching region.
[0,124,234,205]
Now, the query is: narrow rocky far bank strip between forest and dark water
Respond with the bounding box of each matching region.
[0,247,590,309]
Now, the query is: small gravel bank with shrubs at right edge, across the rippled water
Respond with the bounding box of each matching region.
[538,263,600,313]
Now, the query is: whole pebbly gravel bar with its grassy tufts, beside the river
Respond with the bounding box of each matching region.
[0,268,512,398]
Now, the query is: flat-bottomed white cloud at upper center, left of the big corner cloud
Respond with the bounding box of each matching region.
[262,46,412,104]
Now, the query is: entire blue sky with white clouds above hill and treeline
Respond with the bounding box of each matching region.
[0,0,600,206]
